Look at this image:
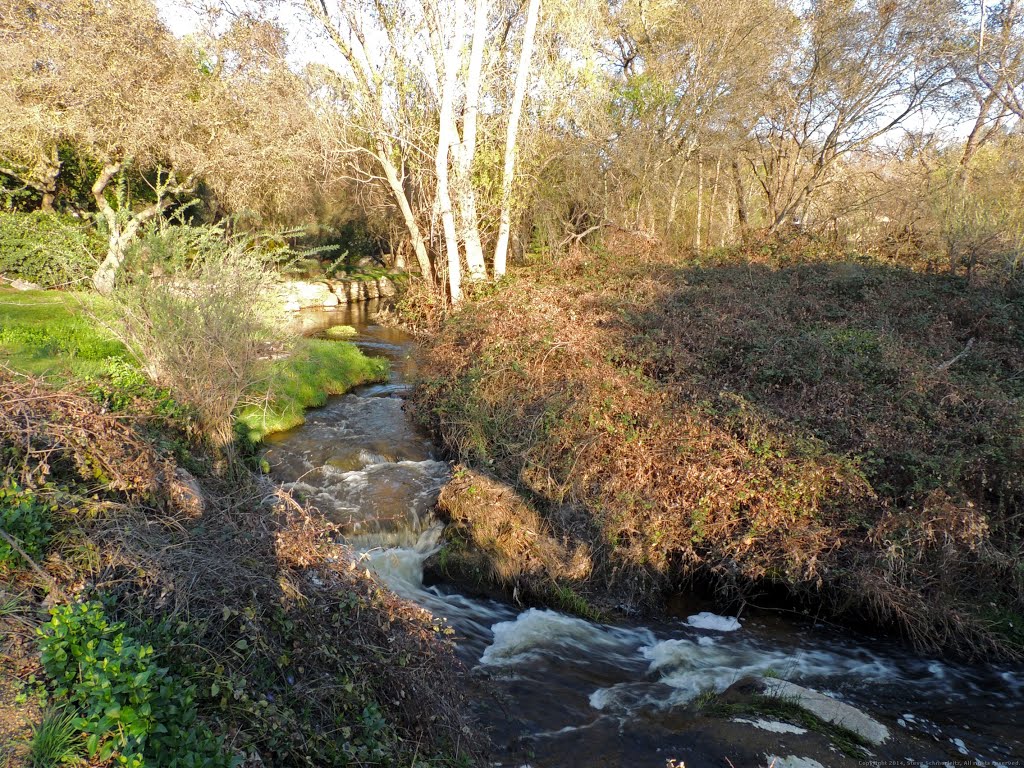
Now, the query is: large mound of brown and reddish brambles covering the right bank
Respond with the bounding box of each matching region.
[415,243,1024,654]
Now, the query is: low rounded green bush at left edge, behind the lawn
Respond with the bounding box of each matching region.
[0,211,104,288]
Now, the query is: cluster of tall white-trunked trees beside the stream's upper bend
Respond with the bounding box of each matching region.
[296,0,557,302]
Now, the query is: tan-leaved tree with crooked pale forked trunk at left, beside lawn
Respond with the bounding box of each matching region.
[0,0,319,293]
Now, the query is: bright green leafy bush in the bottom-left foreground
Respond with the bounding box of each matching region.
[38,601,232,768]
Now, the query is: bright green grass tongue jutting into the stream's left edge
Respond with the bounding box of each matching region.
[238,339,388,442]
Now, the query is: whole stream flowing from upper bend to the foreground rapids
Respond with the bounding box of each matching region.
[267,305,1024,768]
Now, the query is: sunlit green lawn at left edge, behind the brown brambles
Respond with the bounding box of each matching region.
[0,289,128,382]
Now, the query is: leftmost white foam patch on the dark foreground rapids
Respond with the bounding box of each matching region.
[480,608,654,667]
